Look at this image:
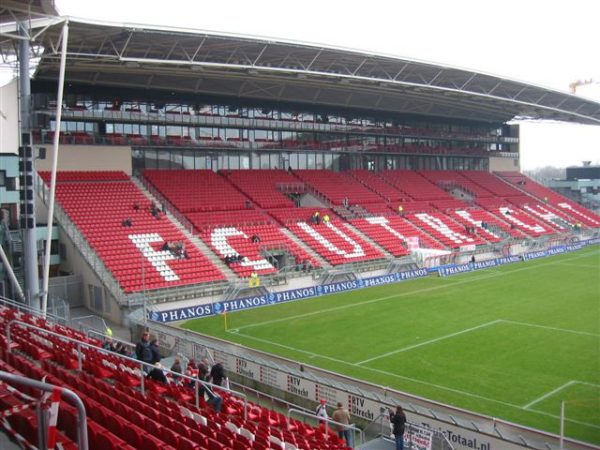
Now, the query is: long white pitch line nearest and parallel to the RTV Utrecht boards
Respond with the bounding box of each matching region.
[229,333,600,429]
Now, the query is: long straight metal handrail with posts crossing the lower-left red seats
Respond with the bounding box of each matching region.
[5,320,248,420]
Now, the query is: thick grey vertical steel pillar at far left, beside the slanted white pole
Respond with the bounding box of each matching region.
[19,21,40,308]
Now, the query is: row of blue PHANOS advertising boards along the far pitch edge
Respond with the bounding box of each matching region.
[148,238,600,323]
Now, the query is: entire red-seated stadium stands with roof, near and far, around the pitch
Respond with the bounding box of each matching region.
[0,0,600,450]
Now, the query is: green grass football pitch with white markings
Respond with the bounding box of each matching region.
[184,246,600,444]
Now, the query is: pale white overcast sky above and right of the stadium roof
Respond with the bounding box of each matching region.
[1,0,600,169]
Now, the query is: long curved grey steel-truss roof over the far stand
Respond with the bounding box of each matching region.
[0,12,600,125]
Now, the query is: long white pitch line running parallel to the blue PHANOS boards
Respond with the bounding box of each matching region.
[238,254,588,330]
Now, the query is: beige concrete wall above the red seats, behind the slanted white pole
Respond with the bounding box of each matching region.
[35,145,131,175]
